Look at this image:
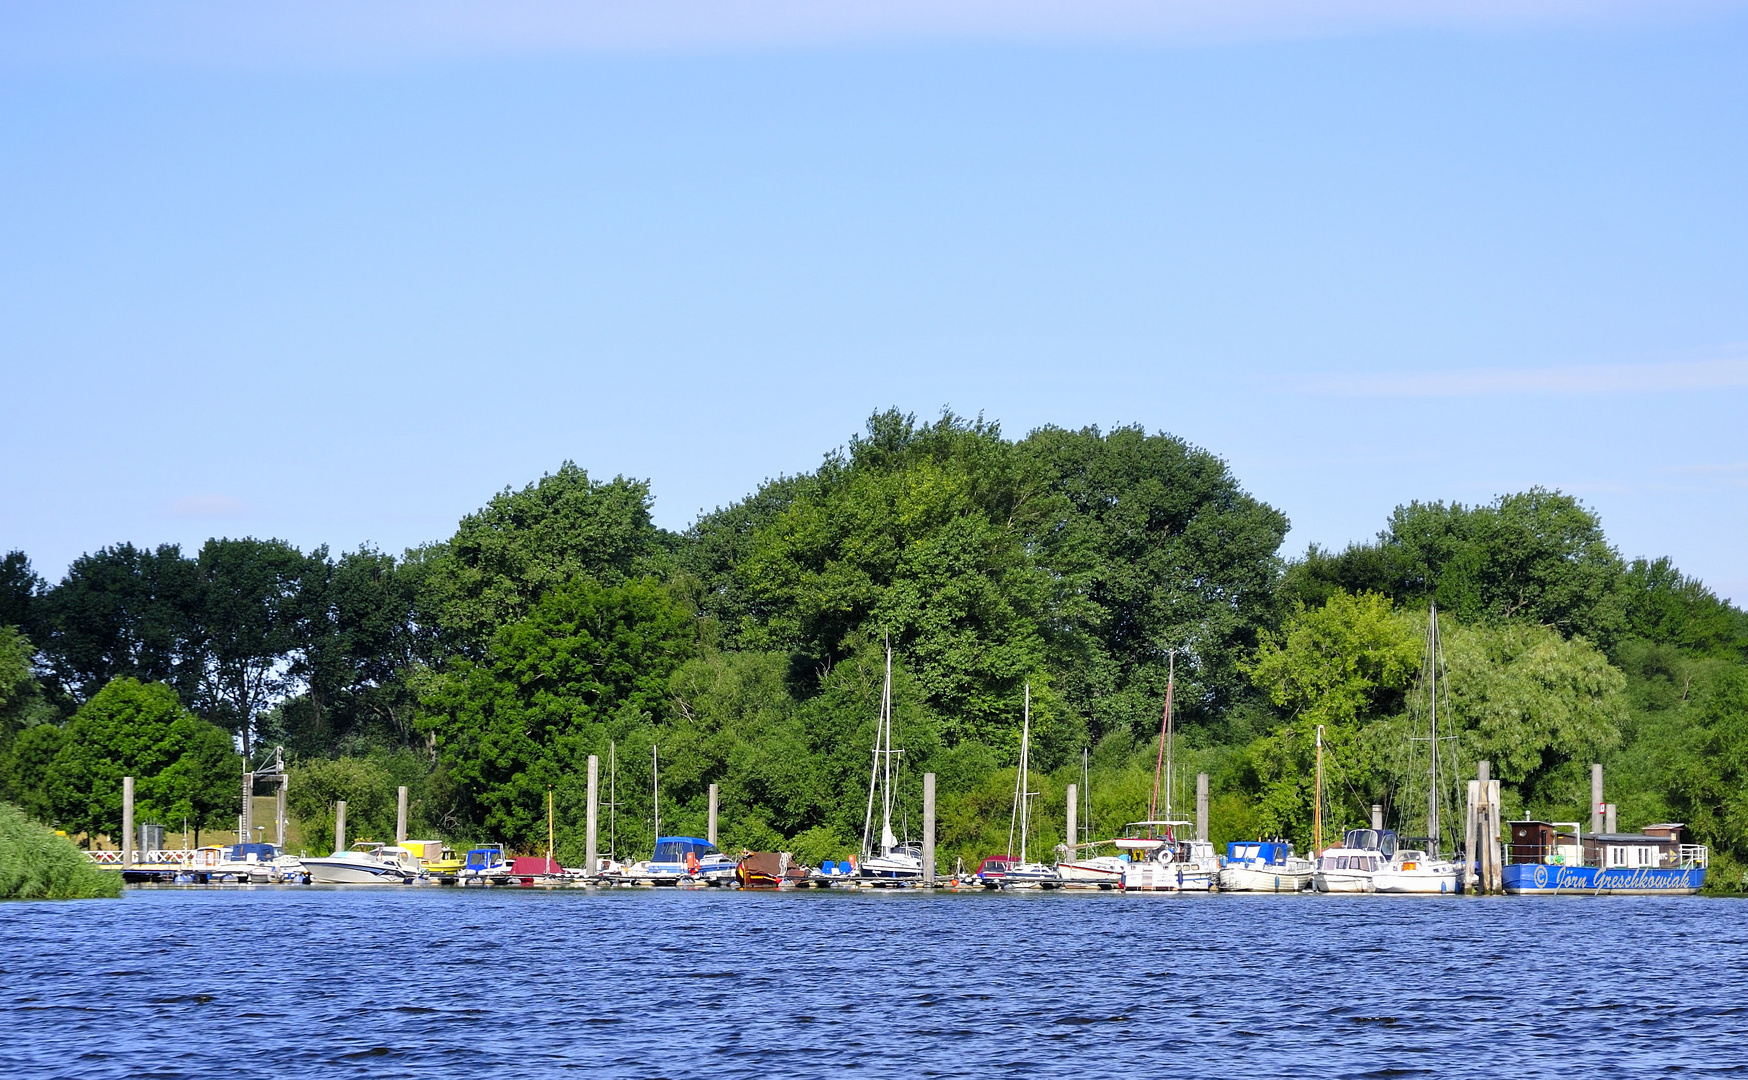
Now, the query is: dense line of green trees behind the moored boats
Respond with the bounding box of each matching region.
[0,411,1748,884]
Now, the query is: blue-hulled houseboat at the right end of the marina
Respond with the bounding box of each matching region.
[1503,821,1710,897]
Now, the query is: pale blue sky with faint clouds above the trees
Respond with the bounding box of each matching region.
[0,0,1748,601]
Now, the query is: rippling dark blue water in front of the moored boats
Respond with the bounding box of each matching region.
[0,888,1748,1080]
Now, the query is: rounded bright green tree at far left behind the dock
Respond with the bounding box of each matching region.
[42,678,243,837]
